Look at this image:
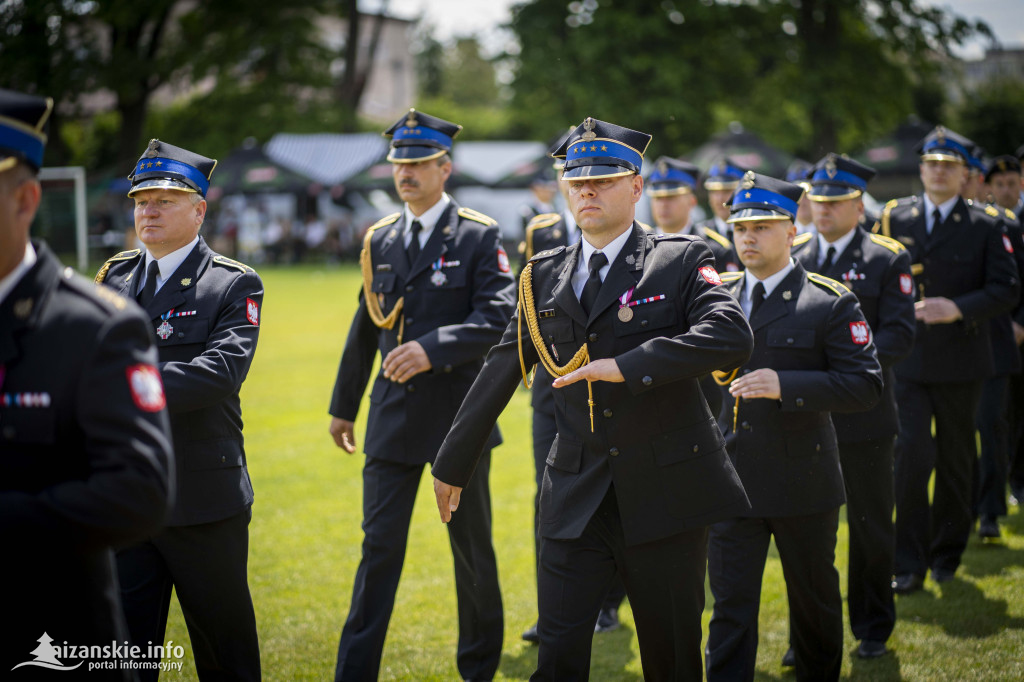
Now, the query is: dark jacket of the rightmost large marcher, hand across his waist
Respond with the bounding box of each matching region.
[879,197,1020,383]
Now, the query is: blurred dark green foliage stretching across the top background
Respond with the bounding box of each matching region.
[0,0,1024,175]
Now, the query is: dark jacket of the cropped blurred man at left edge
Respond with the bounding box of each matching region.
[0,242,172,677]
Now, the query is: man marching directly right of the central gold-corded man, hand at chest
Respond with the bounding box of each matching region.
[706,172,882,681]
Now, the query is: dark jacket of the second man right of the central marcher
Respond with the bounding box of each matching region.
[793,227,914,443]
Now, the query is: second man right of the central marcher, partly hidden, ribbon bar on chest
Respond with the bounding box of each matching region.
[791,154,914,665]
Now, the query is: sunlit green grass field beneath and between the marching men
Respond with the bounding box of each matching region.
[159,265,1024,681]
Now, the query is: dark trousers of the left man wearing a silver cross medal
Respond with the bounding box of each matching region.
[117,507,260,680]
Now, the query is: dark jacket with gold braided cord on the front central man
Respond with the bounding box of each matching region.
[433,223,752,545]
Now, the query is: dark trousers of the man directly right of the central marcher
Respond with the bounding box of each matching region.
[706,507,843,682]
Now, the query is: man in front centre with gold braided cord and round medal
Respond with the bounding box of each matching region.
[433,118,751,681]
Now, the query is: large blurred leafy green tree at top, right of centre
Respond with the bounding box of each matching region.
[508,0,991,158]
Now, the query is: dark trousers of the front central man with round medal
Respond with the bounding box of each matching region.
[530,487,708,682]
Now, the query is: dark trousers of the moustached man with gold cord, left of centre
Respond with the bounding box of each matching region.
[335,451,505,681]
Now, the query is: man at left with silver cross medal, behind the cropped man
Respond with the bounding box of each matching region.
[96,139,263,680]
